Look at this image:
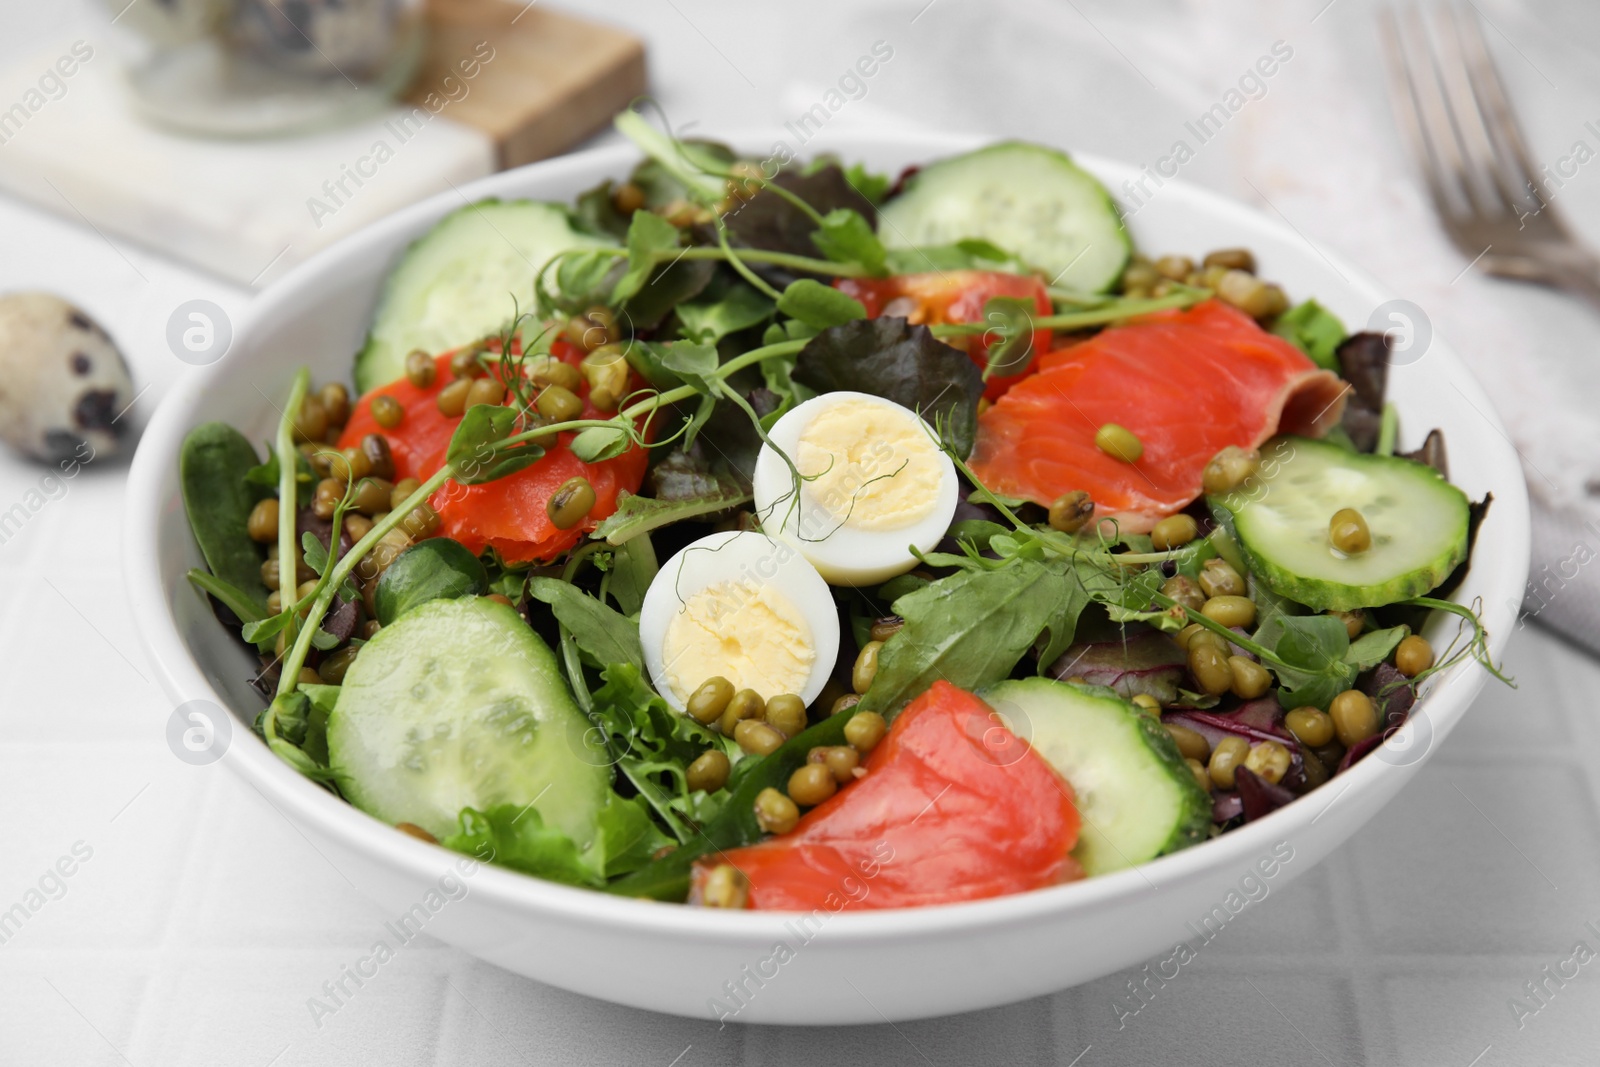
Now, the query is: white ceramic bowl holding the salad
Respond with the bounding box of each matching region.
[125,136,1528,1024]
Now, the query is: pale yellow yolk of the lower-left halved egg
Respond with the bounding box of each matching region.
[661,579,816,701]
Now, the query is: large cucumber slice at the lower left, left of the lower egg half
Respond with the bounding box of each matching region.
[328,597,610,853]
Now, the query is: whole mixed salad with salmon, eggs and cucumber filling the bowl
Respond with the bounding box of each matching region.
[181,114,1493,910]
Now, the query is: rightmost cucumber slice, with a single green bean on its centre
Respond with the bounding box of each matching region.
[1208,437,1467,611]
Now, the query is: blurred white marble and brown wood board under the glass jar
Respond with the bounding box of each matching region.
[0,0,645,286]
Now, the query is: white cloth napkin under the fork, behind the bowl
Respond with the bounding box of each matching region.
[779,0,1600,651]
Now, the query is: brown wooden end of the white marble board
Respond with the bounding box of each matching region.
[406,0,645,170]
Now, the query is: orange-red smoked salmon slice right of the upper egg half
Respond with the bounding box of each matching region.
[968,301,1349,533]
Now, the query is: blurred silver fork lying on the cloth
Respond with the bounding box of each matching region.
[1379,0,1600,306]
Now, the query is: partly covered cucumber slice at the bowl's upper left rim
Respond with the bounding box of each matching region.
[355,200,616,394]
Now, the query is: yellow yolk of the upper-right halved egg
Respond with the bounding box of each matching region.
[795,400,942,530]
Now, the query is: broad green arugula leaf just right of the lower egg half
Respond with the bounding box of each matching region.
[856,558,1083,717]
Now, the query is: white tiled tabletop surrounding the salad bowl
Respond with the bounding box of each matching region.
[0,0,1600,1067]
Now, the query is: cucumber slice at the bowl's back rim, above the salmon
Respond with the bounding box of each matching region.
[878,141,1133,293]
